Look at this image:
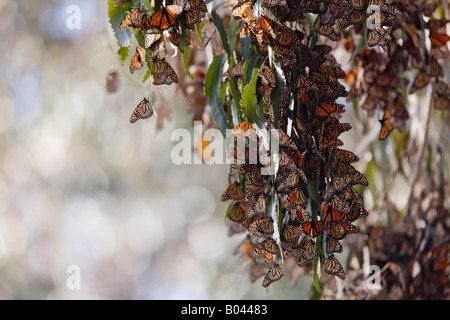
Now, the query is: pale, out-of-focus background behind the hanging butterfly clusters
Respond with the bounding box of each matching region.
[0,0,450,299]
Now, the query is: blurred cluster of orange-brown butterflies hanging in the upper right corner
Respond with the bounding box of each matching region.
[349,0,450,140]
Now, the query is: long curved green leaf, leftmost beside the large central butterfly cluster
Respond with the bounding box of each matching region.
[205,54,232,137]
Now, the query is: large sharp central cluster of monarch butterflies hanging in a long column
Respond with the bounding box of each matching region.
[218,0,376,287]
